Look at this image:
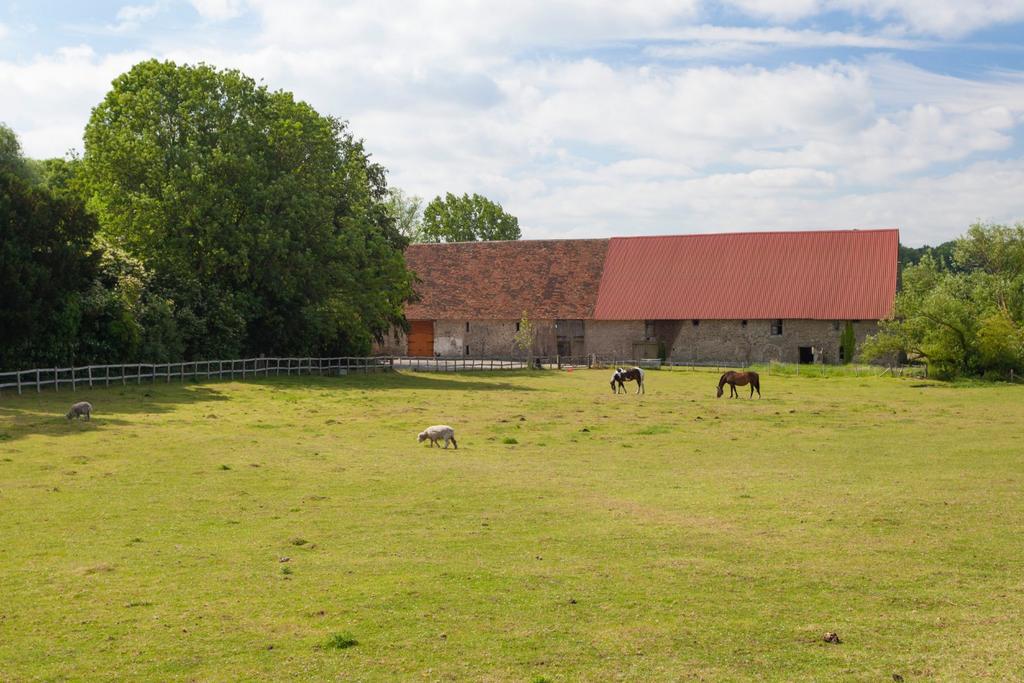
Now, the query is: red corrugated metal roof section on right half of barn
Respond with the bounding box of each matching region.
[594,229,899,321]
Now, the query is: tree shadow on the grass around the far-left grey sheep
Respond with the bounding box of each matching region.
[0,383,229,450]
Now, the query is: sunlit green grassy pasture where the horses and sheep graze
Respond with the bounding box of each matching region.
[0,370,1024,681]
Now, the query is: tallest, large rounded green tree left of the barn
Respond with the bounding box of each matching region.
[81,60,410,357]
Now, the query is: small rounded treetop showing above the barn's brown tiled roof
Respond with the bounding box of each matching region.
[423,193,522,242]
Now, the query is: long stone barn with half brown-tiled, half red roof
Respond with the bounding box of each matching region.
[378,229,899,364]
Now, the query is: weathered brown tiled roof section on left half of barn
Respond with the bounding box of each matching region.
[406,240,608,321]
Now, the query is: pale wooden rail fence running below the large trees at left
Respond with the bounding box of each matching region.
[0,356,393,393]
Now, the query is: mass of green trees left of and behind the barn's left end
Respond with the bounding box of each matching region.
[0,60,519,369]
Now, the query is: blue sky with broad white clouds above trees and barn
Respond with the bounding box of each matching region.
[0,0,1024,246]
